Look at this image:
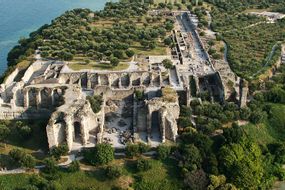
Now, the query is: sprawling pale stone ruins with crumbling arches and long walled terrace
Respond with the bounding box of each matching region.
[0,11,224,151]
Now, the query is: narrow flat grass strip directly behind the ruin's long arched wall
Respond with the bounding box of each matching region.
[68,62,129,71]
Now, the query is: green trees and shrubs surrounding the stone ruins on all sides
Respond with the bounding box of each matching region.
[0,0,285,190]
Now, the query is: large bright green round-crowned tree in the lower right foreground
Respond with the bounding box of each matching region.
[219,141,264,189]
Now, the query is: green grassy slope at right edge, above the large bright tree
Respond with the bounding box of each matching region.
[243,104,285,144]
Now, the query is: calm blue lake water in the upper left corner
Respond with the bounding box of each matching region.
[0,0,113,74]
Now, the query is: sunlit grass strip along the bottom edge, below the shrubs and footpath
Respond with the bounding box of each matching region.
[0,159,182,190]
